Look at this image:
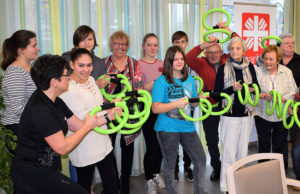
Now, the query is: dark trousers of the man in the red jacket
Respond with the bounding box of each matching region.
[202,113,221,171]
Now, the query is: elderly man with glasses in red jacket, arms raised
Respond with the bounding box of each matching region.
[186,22,238,181]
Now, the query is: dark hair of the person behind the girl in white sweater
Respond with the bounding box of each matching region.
[73,25,98,50]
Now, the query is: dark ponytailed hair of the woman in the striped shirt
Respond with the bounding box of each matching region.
[1,30,36,70]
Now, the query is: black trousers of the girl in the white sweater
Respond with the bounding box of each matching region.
[75,151,119,194]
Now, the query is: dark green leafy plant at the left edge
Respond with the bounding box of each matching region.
[0,75,17,194]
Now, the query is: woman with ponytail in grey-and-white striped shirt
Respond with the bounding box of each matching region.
[1,30,39,134]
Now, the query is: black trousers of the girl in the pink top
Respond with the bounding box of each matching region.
[142,111,162,180]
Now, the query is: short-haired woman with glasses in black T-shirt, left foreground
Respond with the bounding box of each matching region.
[11,55,120,194]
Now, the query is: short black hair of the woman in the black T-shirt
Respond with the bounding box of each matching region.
[30,54,68,90]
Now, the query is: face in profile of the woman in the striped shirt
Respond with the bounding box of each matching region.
[18,38,40,61]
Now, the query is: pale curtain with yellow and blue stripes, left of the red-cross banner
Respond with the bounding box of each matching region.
[0,0,221,178]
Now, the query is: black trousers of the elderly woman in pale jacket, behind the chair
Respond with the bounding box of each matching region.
[254,116,288,167]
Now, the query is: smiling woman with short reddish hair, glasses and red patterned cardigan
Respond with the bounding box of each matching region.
[105,31,143,194]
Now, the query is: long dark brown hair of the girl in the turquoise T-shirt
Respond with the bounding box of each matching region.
[162,46,189,83]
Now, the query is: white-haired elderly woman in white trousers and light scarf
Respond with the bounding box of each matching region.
[214,37,258,193]
